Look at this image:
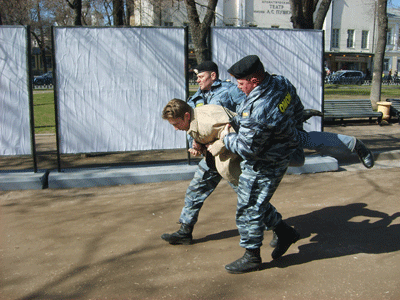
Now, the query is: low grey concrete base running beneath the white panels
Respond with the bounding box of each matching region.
[0,156,339,191]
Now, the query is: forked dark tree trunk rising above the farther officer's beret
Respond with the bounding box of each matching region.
[185,0,218,64]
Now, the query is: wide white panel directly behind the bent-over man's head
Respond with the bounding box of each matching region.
[54,27,186,153]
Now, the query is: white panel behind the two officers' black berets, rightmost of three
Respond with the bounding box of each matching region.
[212,27,323,131]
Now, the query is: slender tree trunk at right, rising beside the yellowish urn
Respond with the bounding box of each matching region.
[371,0,388,105]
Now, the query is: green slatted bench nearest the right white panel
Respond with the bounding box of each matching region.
[324,99,383,124]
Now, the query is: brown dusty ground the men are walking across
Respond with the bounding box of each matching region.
[0,120,400,300]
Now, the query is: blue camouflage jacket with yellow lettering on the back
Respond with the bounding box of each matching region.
[224,73,304,165]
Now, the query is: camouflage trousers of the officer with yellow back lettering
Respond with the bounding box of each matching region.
[236,161,288,249]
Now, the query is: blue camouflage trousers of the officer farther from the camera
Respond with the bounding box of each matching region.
[179,159,237,225]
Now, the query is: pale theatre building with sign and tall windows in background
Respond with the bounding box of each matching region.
[140,0,400,75]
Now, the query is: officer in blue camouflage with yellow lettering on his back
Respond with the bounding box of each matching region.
[221,55,304,273]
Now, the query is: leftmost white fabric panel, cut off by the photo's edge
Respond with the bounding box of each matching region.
[0,26,32,155]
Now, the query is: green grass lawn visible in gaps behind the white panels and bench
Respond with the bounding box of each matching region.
[33,84,400,133]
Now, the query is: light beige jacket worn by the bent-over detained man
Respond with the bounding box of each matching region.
[187,104,241,185]
